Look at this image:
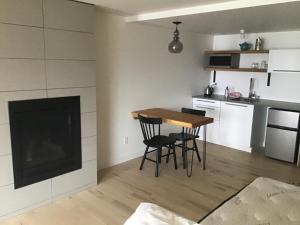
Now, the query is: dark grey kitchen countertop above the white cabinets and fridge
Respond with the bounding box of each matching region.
[193,95,300,112]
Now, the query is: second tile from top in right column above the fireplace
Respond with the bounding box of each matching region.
[45,29,96,60]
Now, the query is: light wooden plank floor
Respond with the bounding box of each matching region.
[0,144,300,225]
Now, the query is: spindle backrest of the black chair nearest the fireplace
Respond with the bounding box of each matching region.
[138,115,162,141]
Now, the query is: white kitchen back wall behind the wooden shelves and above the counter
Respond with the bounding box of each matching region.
[211,31,300,102]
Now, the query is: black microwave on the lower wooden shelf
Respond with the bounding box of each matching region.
[208,54,240,68]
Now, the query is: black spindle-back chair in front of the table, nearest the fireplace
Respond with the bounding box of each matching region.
[138,115,177,177]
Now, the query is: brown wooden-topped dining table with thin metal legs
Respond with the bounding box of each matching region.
[131,108,214,170]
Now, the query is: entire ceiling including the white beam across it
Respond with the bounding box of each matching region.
[81,0,300,34]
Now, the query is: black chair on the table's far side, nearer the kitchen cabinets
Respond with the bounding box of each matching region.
[167,108,206,177]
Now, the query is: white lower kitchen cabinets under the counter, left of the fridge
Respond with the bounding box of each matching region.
[193,98,254,152]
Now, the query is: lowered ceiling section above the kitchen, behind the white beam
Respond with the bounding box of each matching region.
[147,2,300,34]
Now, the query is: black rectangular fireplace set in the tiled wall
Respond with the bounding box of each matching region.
[9,96,82,189]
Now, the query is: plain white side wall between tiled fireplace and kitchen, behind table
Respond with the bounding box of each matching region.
[96,11,212,168]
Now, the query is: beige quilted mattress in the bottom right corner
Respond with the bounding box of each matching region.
[200,177,300,225]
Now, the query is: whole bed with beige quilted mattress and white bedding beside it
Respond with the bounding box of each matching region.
[125,178,300,225]
